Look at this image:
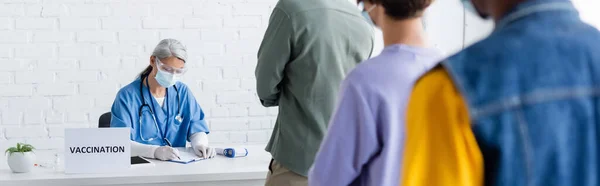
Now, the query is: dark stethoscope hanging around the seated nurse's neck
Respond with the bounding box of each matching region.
[139,75,183,141]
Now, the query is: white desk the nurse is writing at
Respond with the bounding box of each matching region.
[0,146,271,186]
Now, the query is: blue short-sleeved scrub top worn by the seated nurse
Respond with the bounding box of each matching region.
[110,78,209,147]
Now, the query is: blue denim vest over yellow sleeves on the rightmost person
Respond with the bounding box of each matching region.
[442,0,600,186]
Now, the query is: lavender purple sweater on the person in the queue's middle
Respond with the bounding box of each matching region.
[308,44,442,186]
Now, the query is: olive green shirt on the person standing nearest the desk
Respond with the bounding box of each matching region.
[256,0,373,176]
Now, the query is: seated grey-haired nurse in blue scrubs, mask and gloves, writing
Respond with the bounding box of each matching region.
[111,39,216,160]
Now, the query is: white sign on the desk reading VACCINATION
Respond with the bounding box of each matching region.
[65,128,131,174]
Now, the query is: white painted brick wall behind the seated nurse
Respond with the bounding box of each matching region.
[0,0,277,169]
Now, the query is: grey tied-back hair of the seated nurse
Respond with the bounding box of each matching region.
[139,39,187,77]
